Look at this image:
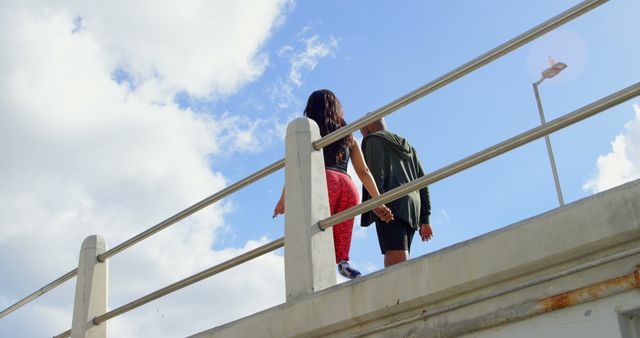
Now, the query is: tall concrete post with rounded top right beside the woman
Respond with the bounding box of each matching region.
[284,117,336,301]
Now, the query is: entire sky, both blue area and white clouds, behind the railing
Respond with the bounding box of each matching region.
[0,0,640,337]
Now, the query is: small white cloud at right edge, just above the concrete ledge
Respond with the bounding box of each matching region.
[582,103,640,193]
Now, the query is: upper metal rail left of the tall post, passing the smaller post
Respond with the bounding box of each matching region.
[0,159,284,318]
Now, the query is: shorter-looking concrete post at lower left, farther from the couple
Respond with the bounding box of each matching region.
[71,235,108,338]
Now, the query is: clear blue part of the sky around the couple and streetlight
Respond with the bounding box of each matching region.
[212,1,640,271]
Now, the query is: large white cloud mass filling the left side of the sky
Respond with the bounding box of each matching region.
[0,0,288,337]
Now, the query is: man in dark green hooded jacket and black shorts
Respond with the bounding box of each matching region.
[360,119,433,267]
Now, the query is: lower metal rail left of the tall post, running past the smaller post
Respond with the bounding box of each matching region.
[54,237,284,338]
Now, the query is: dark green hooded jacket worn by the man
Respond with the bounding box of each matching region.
[361,131,431,230]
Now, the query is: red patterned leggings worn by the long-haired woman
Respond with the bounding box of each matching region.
[325,169,360,263]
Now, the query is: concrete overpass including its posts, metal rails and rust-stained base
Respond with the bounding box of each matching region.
[0,0,640,338]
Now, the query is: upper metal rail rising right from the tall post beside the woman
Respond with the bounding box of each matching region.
[313,0,608,150]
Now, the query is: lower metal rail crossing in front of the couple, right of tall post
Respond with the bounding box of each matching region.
[318,82,640,230]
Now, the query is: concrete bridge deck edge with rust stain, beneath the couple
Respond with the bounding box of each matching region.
[192,180,640,338]
